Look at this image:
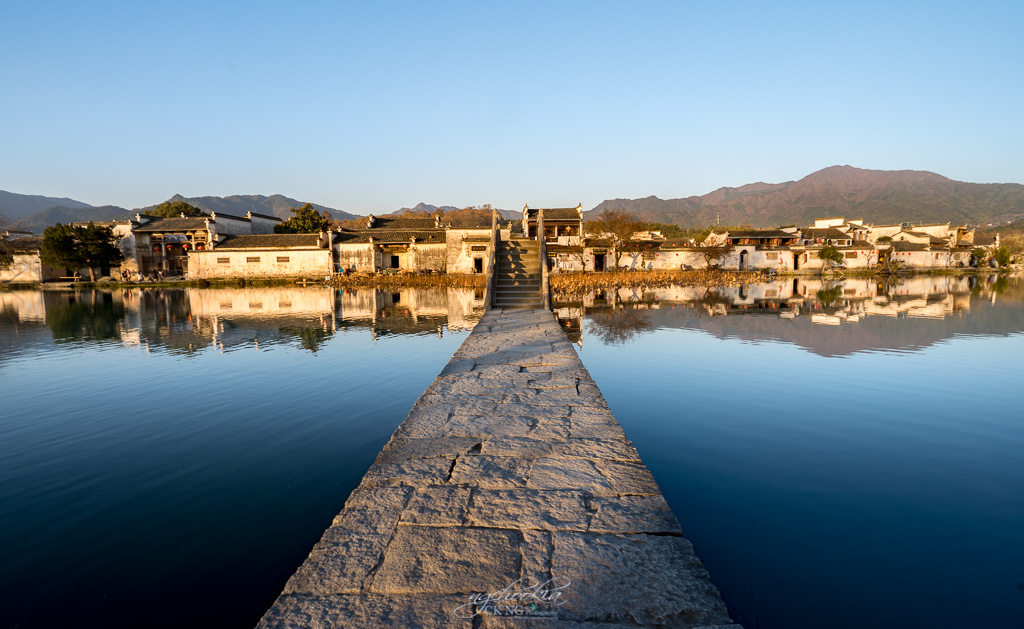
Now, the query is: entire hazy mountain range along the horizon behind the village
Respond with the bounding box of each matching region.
[0,166,1024,234]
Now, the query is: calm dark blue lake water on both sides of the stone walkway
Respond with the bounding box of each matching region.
[0,277,1024,629]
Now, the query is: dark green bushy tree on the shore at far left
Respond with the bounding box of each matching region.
[39,222,124,282]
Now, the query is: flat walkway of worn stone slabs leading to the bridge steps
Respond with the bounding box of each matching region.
[253,309,738,629]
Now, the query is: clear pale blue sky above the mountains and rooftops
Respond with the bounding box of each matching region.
[0,0,1024,214]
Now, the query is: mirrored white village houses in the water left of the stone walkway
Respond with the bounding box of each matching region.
[0,287,483,360]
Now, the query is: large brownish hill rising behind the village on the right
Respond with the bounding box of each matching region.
[587,166,1024,227]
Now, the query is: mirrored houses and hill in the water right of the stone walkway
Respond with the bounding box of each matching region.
[556,277,1024,357]
